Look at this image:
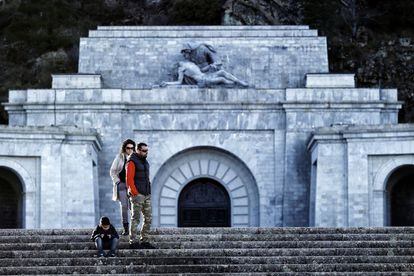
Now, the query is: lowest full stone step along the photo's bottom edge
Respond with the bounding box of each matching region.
[0,263,414,275]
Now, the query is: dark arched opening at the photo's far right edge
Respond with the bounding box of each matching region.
[387,165,414,226]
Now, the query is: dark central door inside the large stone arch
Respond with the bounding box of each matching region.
[178,178,231,227]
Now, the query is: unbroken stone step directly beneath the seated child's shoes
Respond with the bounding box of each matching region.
[0,256,414,267]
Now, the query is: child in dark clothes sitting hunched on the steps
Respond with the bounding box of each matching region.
[91,217,119,257]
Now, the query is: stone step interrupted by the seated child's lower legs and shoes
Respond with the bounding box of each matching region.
[0,247,414,258]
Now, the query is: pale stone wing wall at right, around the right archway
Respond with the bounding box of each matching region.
[309,124,414,227]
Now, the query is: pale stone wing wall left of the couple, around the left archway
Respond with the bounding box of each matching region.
[0,126,101,228]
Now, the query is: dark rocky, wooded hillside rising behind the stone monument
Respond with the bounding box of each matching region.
[0,0,414,123]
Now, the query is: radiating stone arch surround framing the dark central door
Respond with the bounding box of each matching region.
[151,147,260,227]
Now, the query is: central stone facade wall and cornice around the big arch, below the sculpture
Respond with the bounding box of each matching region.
[7,82,400,229]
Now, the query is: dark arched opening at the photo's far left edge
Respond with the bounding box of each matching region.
[0,167,23,229]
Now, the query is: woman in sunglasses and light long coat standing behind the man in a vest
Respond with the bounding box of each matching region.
[109,139,135,236]
